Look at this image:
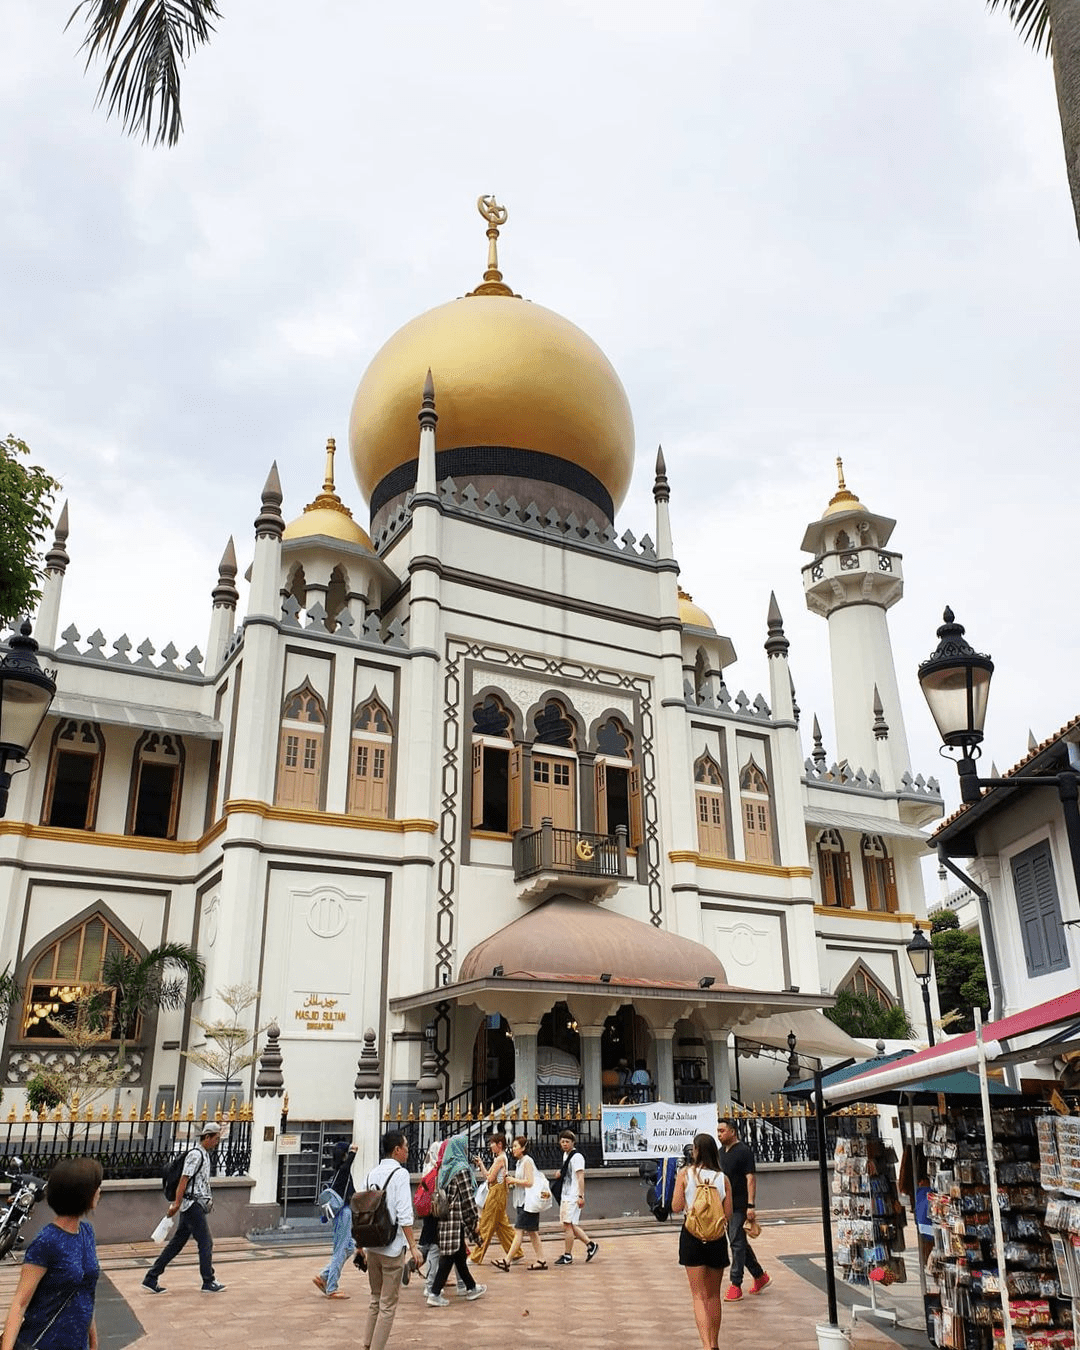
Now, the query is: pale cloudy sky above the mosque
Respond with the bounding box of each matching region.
[0,0,1080,831]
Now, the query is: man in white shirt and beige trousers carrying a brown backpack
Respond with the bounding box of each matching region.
[350,1130,424,1350]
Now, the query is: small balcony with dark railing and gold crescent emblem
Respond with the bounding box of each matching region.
[514,817,629,900]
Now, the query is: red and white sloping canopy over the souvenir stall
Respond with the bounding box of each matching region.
[825,990,1080,1104]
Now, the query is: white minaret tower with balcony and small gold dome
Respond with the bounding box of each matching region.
[802,459,910,791]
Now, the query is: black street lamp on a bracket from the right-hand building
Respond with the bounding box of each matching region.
[919,608,1080,895]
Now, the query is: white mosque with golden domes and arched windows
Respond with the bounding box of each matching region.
[0,198,942,1150]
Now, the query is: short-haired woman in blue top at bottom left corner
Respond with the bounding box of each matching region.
[0,1158,101,1350]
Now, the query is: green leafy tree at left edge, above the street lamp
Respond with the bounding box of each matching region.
[0,436,59,625]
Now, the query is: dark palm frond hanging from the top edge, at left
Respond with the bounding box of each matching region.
[68,0,221,146]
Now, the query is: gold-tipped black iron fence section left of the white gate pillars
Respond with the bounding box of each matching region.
[0,1107,251,1181]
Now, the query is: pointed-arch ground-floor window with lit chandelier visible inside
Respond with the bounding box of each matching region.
[22,914,139,1041]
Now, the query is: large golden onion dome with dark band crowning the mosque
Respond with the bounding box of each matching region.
[348,202,633,513]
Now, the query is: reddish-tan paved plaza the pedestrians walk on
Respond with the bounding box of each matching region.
[0,1222,926,1350]
